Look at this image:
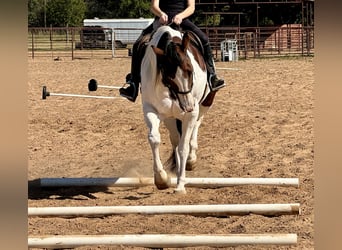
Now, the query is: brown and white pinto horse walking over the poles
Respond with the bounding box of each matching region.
[141,26,216,193]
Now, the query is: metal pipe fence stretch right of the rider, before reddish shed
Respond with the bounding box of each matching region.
[206,24,314,59]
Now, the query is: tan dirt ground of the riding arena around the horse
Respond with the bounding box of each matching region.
[28,52,314,250]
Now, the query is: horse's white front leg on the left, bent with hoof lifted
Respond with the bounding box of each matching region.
[145,112,171,189]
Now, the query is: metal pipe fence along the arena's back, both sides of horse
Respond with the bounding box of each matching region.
[27,24,314,60]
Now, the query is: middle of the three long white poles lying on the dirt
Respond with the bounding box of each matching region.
[28,203,300,217]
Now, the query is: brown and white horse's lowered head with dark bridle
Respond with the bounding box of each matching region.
[152,32,195,112]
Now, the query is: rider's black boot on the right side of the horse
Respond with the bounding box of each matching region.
[203,43,226,91]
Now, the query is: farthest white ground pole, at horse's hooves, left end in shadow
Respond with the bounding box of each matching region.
[36,177,299,188]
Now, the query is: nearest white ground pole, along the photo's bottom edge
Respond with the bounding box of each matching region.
[28,234,297,249]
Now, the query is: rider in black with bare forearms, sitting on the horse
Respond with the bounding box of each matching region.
[119,0,225,102]
